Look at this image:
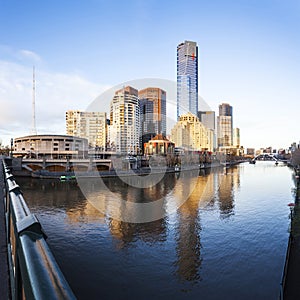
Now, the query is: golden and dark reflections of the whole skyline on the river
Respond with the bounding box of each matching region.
[20,168,240,283]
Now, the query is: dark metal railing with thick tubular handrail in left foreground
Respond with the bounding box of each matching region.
[0,161,76,300]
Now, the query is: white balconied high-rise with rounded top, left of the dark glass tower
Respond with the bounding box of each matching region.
[108,86,141,154]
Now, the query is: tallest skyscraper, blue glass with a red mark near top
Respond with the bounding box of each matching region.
[177,41,198,120]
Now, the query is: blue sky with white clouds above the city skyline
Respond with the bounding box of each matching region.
[0,0,300,149]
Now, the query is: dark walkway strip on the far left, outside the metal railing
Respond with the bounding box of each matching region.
[0,157,10,299]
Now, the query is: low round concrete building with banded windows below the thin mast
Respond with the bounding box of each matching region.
[14,134,88,158]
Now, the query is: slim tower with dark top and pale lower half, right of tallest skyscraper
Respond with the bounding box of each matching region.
[217,103,233,148]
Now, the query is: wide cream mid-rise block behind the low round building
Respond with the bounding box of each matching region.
[66,110,107,150]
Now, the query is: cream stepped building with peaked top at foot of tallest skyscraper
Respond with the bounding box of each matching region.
[171,112,214,151]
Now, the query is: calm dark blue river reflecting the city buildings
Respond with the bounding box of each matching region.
[17,161,294,300]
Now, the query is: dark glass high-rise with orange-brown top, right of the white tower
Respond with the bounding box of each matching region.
[138,87,167,145]
